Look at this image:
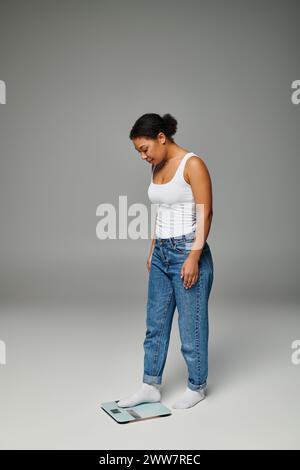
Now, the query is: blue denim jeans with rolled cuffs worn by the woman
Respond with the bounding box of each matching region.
[143,232,214,390]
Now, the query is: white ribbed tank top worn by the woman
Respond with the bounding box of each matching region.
[148,152,198,238]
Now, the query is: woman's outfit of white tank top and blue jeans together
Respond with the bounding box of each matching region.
[143,152,214,390]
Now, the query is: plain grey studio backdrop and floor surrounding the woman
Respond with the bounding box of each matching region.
[0,0,300,449]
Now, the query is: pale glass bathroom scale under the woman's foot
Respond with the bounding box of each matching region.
[101,400,172,424]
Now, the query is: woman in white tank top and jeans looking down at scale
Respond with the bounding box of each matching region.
[118,113,214,409]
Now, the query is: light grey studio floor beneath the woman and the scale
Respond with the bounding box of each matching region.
[0,297,300,449]
